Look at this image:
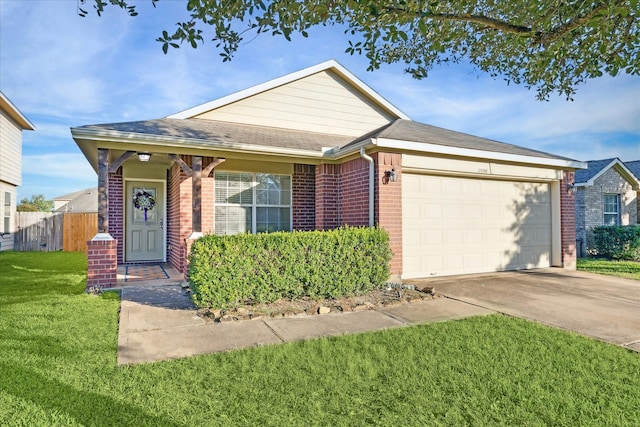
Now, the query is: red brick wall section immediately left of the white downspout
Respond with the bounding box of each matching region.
[338,158,369,227]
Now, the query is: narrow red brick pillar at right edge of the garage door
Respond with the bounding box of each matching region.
[560,171,577,270]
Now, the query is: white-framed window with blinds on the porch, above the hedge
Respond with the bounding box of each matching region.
[215,172,291,234]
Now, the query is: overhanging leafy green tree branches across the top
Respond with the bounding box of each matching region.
[79,0,640,99]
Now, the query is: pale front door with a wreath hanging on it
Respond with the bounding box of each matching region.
[125,181,164,262]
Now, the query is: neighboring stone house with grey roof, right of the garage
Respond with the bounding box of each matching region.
[574,158,640,255]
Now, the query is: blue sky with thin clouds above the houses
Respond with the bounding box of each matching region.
[0,0,640,199]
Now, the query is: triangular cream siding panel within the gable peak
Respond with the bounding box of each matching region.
[195,70,397,136]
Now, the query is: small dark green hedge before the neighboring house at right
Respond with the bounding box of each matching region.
[591,225,640,261]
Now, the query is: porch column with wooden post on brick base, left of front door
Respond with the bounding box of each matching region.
[86,148,118,291]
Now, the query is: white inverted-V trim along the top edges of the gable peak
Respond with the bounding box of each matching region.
[167,59,411,120]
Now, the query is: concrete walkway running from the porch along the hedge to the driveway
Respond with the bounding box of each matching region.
[118,284,493,365]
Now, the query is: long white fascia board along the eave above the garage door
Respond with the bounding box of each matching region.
[375,138,587,169]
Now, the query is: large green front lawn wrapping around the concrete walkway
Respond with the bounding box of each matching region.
[0,253,640,426]
